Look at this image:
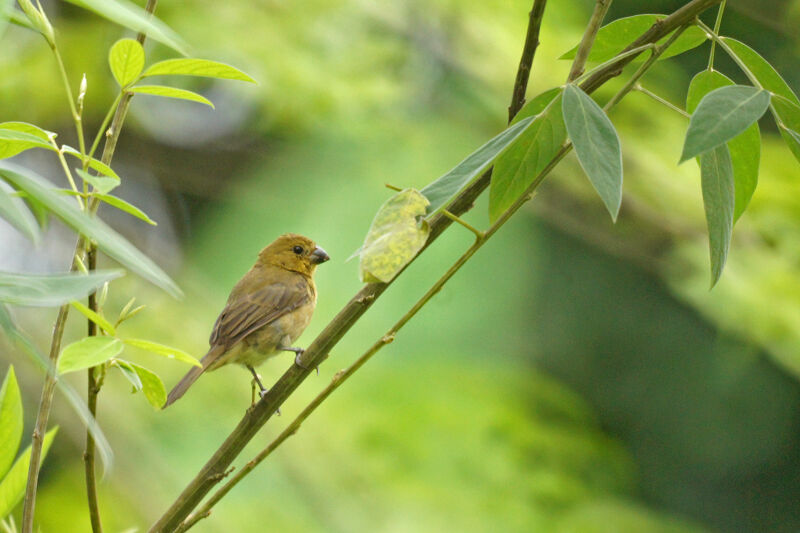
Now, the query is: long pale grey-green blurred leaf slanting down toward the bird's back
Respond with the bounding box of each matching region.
[0,163,181,297]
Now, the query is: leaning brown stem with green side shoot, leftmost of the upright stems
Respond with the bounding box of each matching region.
[21,0,158,533]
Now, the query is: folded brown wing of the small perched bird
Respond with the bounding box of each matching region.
[209,280,311,348]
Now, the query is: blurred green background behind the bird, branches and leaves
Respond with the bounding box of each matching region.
[0,0,800,533]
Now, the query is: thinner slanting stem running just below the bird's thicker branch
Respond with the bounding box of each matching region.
[175,9,696,533]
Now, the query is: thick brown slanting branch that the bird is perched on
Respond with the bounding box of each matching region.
[150,0,720,532]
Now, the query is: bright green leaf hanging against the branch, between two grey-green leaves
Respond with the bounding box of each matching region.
[489,88,567,222]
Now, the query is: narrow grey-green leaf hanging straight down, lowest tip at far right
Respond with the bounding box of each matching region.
[700,144,736,288]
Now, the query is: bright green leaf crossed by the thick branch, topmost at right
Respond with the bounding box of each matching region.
[559,14,708,63]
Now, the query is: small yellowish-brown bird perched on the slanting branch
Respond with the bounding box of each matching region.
[164,233,330,408]
